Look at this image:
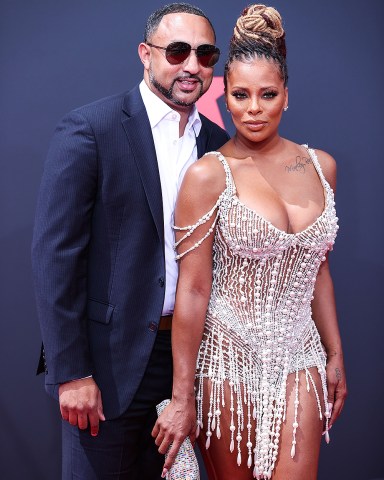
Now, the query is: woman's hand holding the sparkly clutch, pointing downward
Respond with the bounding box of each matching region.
[152,397,197,478]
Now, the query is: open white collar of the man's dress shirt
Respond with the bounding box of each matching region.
[139,80,201,137]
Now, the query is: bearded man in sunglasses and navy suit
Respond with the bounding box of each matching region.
[32,3,228,480]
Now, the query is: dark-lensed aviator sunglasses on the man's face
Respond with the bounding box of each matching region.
[146,42,220,68]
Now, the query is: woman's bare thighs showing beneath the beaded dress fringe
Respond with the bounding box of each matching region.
[197,368,324,480]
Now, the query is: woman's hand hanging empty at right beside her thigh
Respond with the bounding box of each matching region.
[326,353,347,428]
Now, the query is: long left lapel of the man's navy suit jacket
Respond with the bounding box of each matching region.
[122,87,164,244]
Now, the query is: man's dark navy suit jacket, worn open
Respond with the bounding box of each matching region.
[32,87,228,418]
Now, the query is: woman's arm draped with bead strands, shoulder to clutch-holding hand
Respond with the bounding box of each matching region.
[152,156,225,475]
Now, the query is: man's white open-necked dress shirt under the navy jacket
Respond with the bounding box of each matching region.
[140,80,201,315]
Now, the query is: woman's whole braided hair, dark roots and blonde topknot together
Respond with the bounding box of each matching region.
[224,4,288,88]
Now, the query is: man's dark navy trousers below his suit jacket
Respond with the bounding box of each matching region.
[62,331,172,480]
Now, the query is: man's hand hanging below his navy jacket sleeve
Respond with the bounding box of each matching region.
[59,378,105,437]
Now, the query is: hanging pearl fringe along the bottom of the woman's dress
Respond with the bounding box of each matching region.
[196,314,328,478]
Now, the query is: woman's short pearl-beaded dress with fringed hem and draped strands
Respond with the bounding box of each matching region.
[175,146,338,479]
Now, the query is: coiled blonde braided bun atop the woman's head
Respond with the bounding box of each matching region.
[233,4,286,56]
